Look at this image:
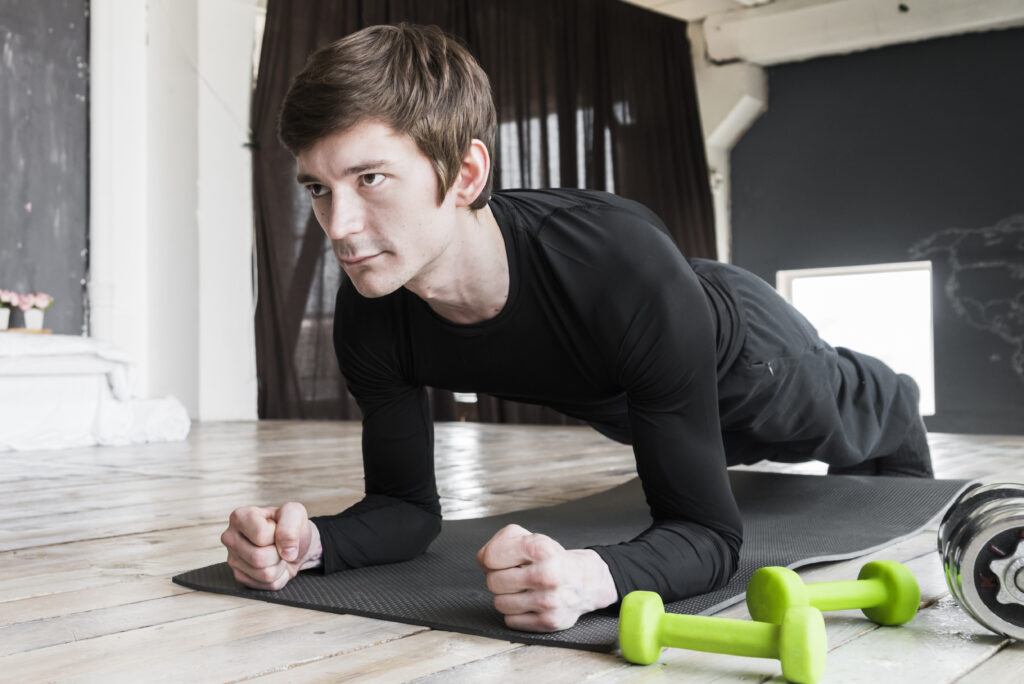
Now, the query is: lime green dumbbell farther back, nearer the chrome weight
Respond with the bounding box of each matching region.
[746,560,921,625]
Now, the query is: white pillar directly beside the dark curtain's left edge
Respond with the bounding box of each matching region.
[199,0,260,420]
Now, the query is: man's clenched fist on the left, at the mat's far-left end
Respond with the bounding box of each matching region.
[220,503,323,591]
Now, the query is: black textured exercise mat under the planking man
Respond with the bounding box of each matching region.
[174,471,968,651]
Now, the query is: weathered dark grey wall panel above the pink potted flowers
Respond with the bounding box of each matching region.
[0,0,89,334]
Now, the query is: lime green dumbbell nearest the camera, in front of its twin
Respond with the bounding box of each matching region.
[618,592,826,684]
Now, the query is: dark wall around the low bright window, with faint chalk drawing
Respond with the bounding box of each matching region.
[731,29,1024,434]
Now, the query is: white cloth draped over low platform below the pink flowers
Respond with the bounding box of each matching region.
[0,332,191,452]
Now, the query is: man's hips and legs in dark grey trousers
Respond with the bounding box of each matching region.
[698,259,931,476]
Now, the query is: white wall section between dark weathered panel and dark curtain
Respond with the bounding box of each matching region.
[89,0,259,420]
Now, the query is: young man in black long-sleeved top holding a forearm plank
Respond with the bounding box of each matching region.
[222,20,931,631]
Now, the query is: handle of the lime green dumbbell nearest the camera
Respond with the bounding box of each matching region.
[658,613,779,658]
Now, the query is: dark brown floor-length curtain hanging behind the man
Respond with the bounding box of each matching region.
[252,0,715,423]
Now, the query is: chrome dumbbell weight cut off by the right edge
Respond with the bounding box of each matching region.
[938,483,1024,639]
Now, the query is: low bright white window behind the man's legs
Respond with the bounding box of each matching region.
[775,261,935,416]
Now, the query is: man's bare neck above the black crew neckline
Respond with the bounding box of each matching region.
[406,202,509,325]
